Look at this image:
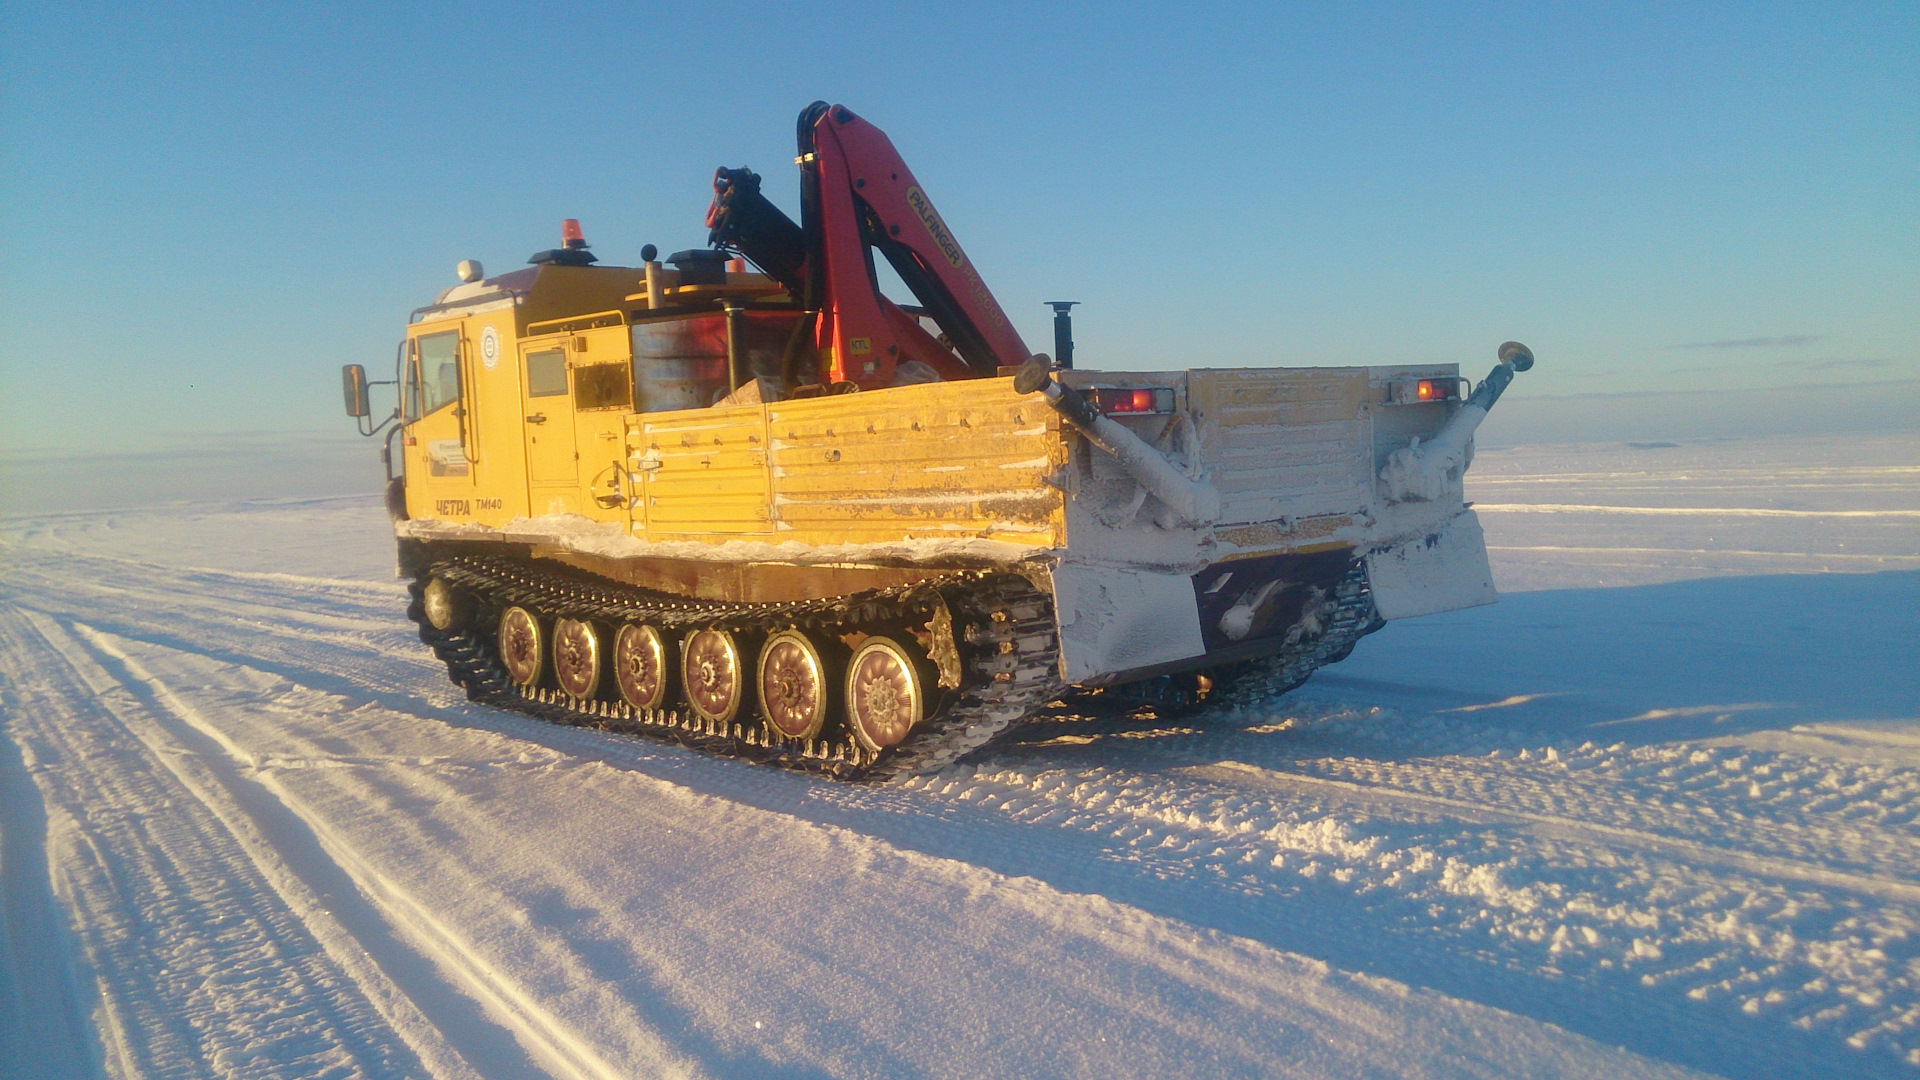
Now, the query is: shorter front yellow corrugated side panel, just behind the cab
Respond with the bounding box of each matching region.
[630,405,774,540]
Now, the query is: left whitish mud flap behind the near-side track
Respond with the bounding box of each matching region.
[1054,563,1206,682]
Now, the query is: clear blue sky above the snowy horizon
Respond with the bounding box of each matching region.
[0,2,1920,450]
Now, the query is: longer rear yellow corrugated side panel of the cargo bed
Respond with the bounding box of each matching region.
[766,379,1066,546]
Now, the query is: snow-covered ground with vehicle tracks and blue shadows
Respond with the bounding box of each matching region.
[0,436,1920,1080]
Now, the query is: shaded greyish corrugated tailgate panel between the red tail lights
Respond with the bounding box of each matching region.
[1187,367,1373,523]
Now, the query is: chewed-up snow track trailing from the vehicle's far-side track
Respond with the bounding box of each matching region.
[979,698,1920,883]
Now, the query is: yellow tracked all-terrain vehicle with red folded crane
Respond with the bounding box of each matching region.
[344,104,1532,778]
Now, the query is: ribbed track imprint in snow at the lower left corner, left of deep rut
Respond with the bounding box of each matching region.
[0,611,449,1080]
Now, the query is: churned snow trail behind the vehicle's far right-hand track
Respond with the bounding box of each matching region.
[981,700,1920,903]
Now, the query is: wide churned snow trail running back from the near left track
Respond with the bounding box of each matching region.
[916,711,1920,1076]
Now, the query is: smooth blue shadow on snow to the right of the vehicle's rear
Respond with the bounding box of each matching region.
[1309,571,1920,746]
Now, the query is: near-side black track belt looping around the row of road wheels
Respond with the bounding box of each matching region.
[407,555,1066,780]
